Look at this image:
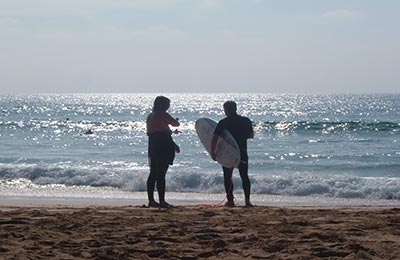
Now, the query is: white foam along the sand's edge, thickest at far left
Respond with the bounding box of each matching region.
[0,179,400,207]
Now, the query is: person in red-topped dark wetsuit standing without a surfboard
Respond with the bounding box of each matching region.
[146,96,180,208]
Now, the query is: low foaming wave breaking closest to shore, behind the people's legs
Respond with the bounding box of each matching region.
[0,162,400,200]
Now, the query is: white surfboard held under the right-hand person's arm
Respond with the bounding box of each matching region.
[195,118,240,168]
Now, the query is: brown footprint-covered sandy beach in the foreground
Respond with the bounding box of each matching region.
[0,199,400,259]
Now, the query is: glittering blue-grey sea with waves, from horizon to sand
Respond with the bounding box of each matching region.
[0,93,400,205]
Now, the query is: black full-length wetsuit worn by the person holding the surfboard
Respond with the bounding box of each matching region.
[214,114,253,202]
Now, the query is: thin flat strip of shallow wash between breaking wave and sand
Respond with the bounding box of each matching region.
[0,192,400,208]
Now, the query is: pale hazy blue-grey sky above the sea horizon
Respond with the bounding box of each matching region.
[0,0,400,94]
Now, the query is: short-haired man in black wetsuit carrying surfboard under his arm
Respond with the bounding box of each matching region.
[211,101,254,207]
